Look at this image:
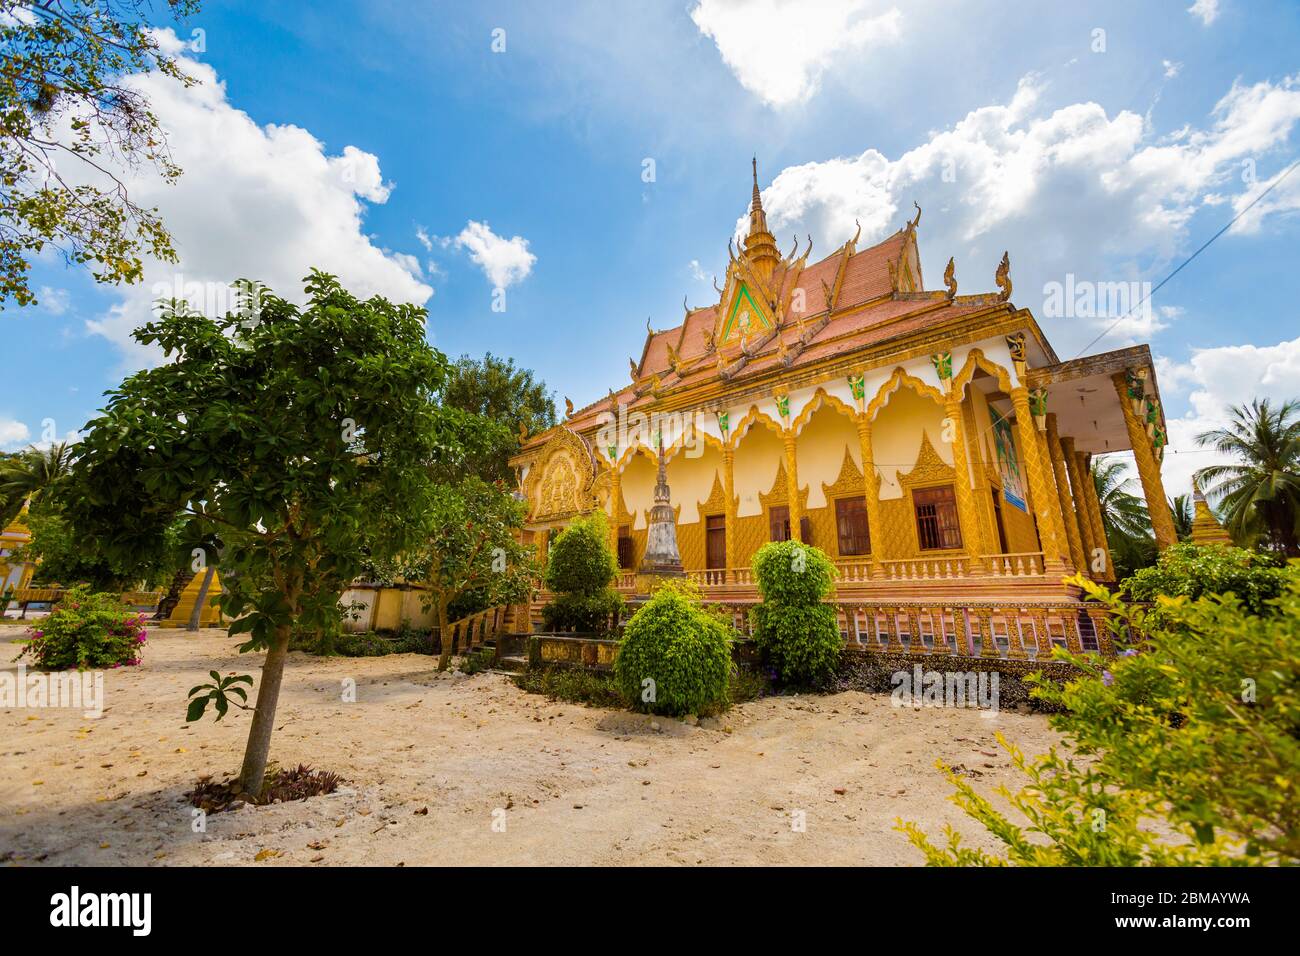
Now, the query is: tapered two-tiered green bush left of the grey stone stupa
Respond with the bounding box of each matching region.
[542,511,623,633]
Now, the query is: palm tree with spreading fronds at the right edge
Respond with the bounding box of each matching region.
[1196,398,1300,558]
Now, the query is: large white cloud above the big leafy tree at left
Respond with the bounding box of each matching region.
[77,33,433,368]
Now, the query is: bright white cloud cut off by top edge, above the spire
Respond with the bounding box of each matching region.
[690,0,902,107]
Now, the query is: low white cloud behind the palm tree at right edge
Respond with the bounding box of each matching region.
[1156,338,1300,496]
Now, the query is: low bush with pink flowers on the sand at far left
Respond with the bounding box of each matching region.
[14,588,148,670]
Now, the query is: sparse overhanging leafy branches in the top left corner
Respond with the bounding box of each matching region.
[0,0,199,307]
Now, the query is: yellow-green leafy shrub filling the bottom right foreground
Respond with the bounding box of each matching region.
[900,572,1300,866]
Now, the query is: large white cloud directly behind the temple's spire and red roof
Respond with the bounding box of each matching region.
[737,75,1300,358]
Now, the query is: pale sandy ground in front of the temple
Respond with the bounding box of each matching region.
[0,626,1056,866]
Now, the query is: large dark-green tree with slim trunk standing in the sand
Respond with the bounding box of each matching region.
[68,272,460,795]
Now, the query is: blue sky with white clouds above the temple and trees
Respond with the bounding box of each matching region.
[0,0,1300,492]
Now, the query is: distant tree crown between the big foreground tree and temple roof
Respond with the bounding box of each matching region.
[442,352,555,481]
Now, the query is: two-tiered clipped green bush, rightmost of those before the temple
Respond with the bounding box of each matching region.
[750,541,844,684]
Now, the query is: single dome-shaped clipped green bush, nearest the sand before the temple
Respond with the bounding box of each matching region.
[614,584,733,715]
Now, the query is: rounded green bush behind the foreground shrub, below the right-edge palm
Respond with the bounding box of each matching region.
[1125,542,1287,614]
